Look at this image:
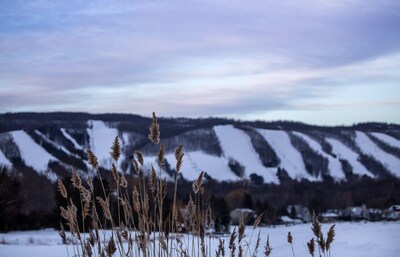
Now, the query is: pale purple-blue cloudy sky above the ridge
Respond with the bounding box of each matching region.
[0,0,400,125]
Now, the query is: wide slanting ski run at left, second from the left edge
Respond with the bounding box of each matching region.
[11,130,57,181]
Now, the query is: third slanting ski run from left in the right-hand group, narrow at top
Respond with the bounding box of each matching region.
[293,132,345,180]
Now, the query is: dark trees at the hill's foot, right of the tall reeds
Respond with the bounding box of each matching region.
[206,175,400,224]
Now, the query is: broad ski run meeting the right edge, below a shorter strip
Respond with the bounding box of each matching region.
[355,131,400,177]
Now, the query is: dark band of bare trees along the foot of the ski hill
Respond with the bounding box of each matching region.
[0,164,400,231]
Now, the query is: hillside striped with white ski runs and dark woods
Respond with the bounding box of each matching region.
[0,113,400,183]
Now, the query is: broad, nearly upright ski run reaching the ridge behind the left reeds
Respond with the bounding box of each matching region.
[87,120,123,168]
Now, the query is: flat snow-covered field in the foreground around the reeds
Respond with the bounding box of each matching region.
[0,222,400,257]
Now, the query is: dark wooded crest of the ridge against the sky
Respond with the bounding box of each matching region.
[0,112,400,135]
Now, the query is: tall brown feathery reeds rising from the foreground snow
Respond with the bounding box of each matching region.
[58,113,334,257]
